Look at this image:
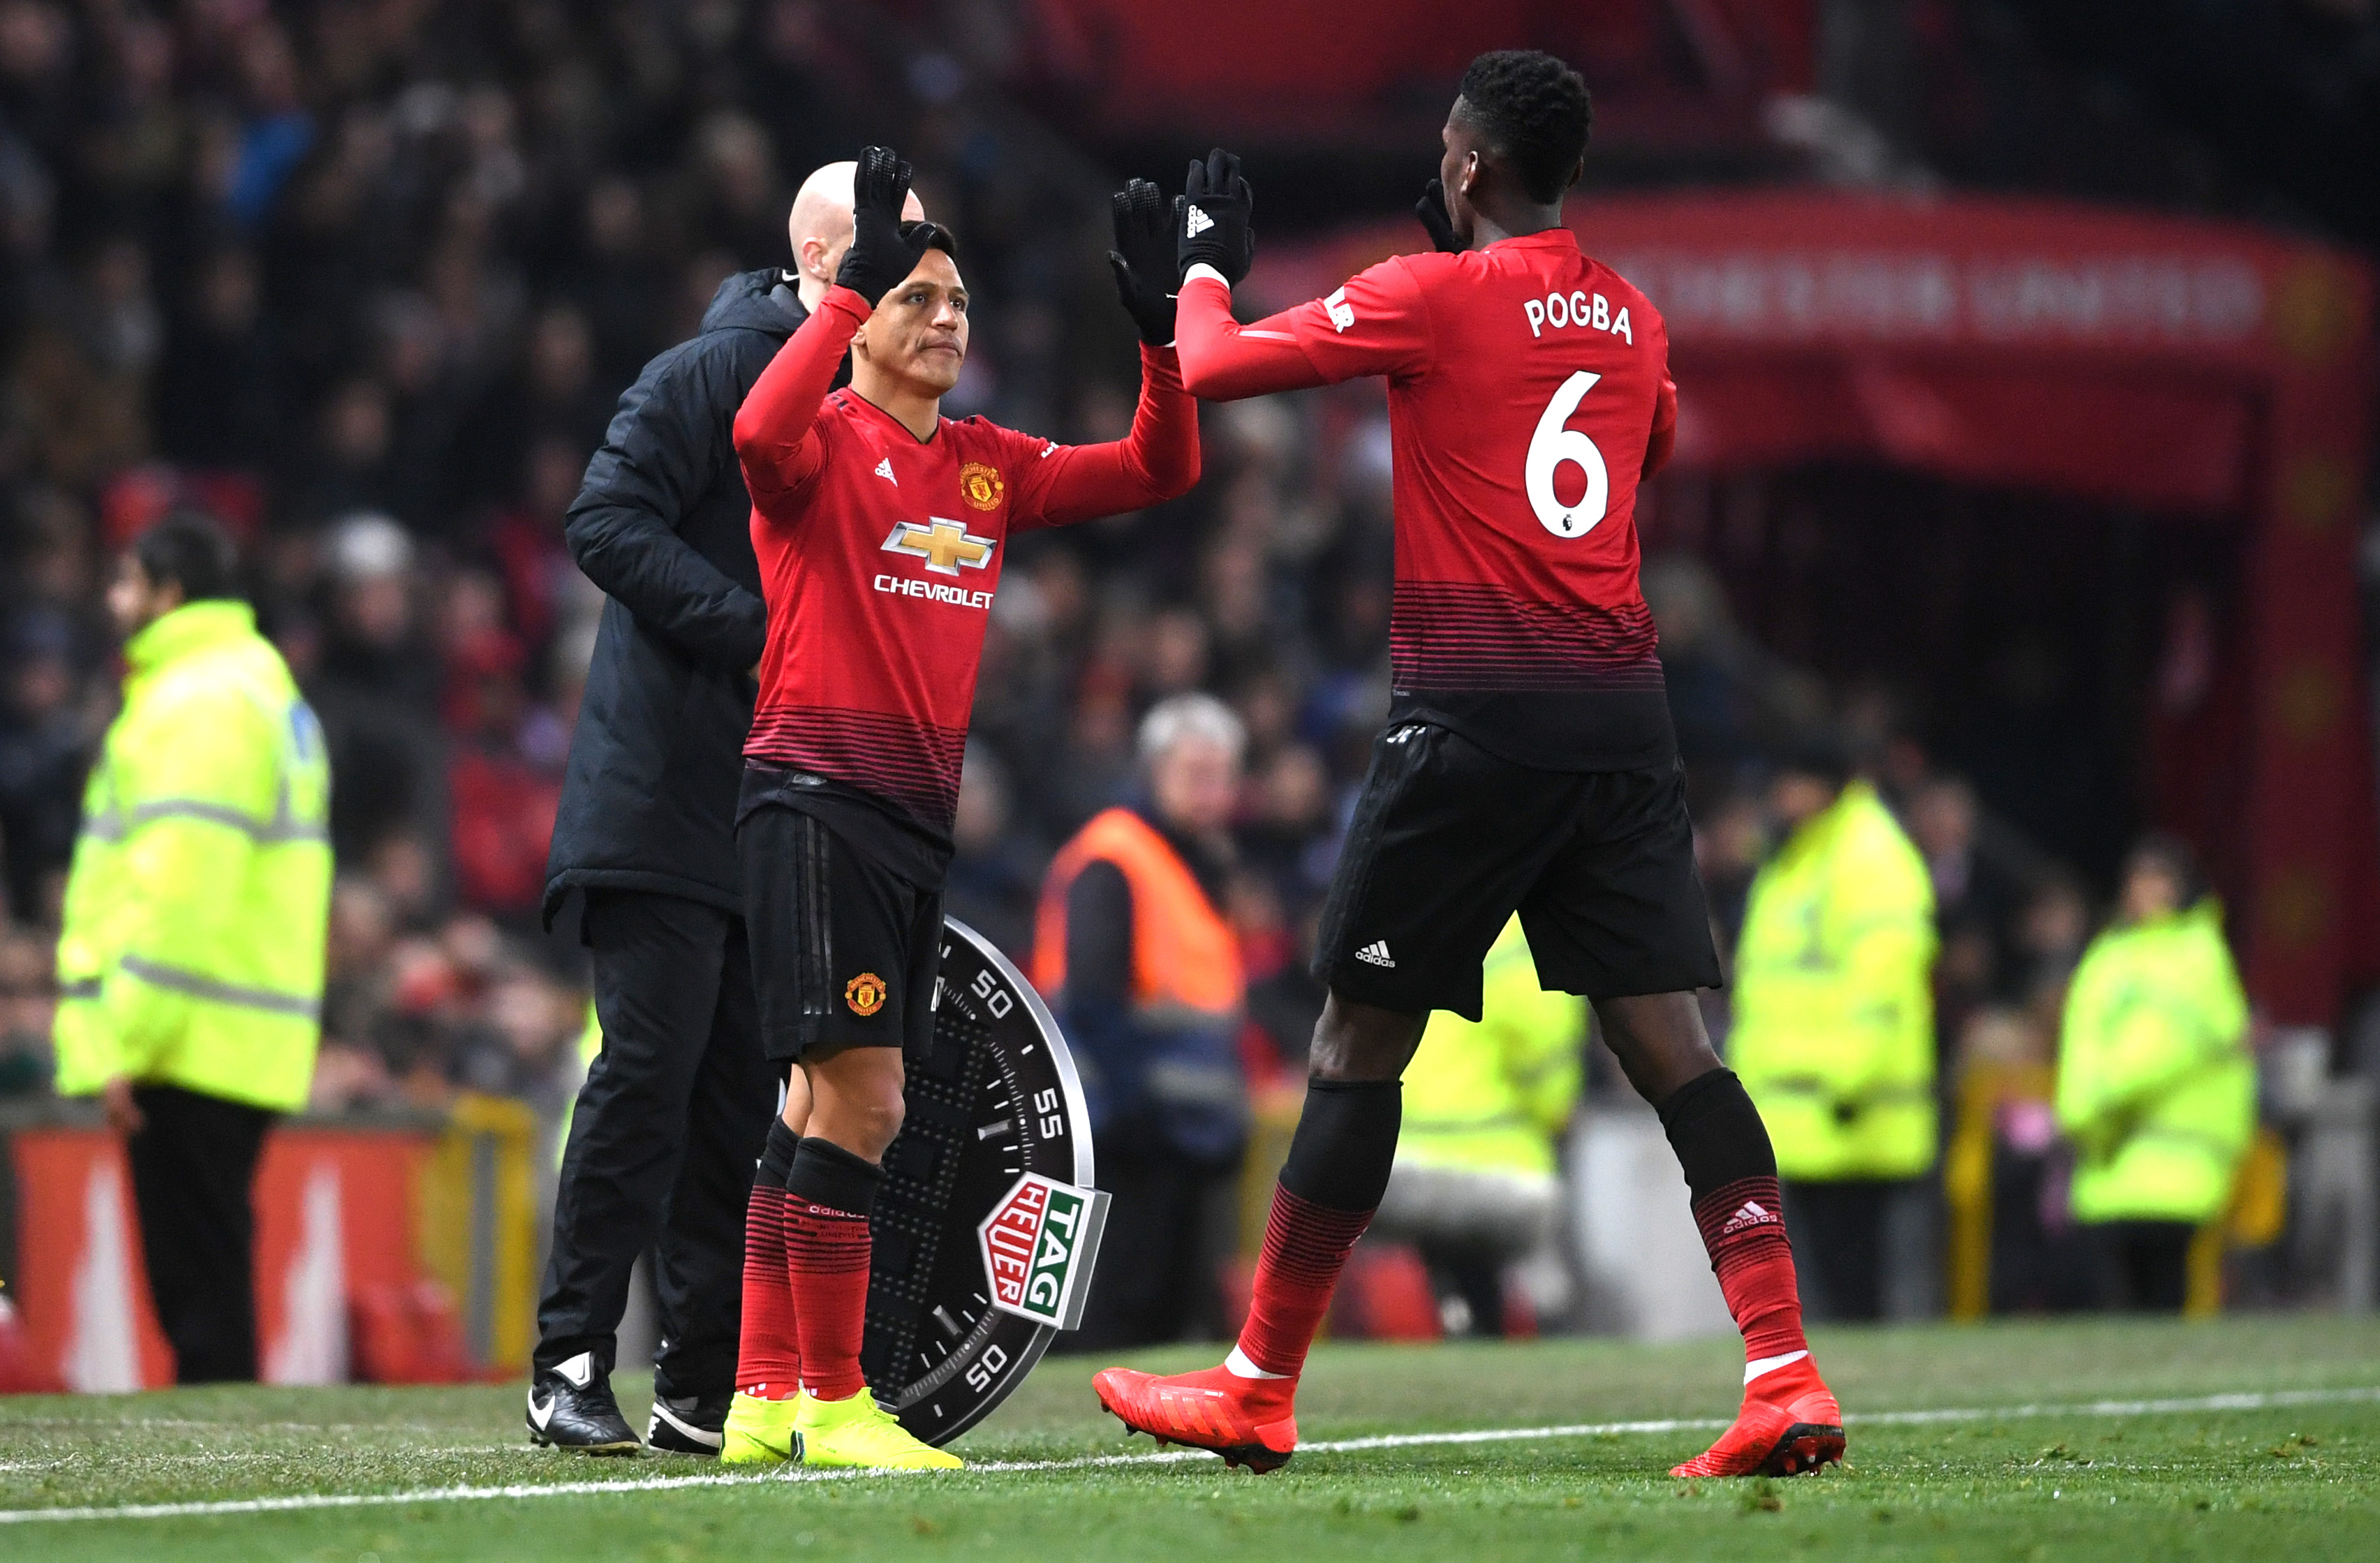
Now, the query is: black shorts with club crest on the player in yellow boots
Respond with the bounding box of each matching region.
[735,804,943,1063]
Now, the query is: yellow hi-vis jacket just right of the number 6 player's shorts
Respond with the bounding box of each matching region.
[1728,780,1935,1183]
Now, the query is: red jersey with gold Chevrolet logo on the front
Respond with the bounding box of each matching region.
[735,288,1199,861]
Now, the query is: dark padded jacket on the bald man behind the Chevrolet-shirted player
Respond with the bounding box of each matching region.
[545,269,804,923]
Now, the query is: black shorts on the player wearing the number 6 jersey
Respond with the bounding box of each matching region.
[1314,723,1721,1021]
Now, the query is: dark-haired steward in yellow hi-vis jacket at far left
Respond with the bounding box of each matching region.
[57,517,331,1384]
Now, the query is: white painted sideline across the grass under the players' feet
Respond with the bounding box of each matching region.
[0,1387,2380,1525]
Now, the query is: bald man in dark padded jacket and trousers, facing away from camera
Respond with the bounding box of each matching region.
[529,162,924,1453]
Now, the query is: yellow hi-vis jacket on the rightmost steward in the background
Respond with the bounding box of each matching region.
[2056,897,2256,1223]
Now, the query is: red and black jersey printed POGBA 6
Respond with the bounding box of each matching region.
[1181,228,1678,771]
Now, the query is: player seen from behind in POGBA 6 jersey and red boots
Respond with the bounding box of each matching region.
[1093,50,1845,1475]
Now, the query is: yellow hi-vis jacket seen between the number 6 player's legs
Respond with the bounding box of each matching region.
[1397,918,1588,1178]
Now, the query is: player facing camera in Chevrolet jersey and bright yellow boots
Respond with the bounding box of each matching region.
[721,147,1199,1470]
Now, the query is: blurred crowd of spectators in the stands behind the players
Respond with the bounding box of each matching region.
[0,0,2294,1313]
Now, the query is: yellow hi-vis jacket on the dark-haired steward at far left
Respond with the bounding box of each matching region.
[57,600,331,1111]
